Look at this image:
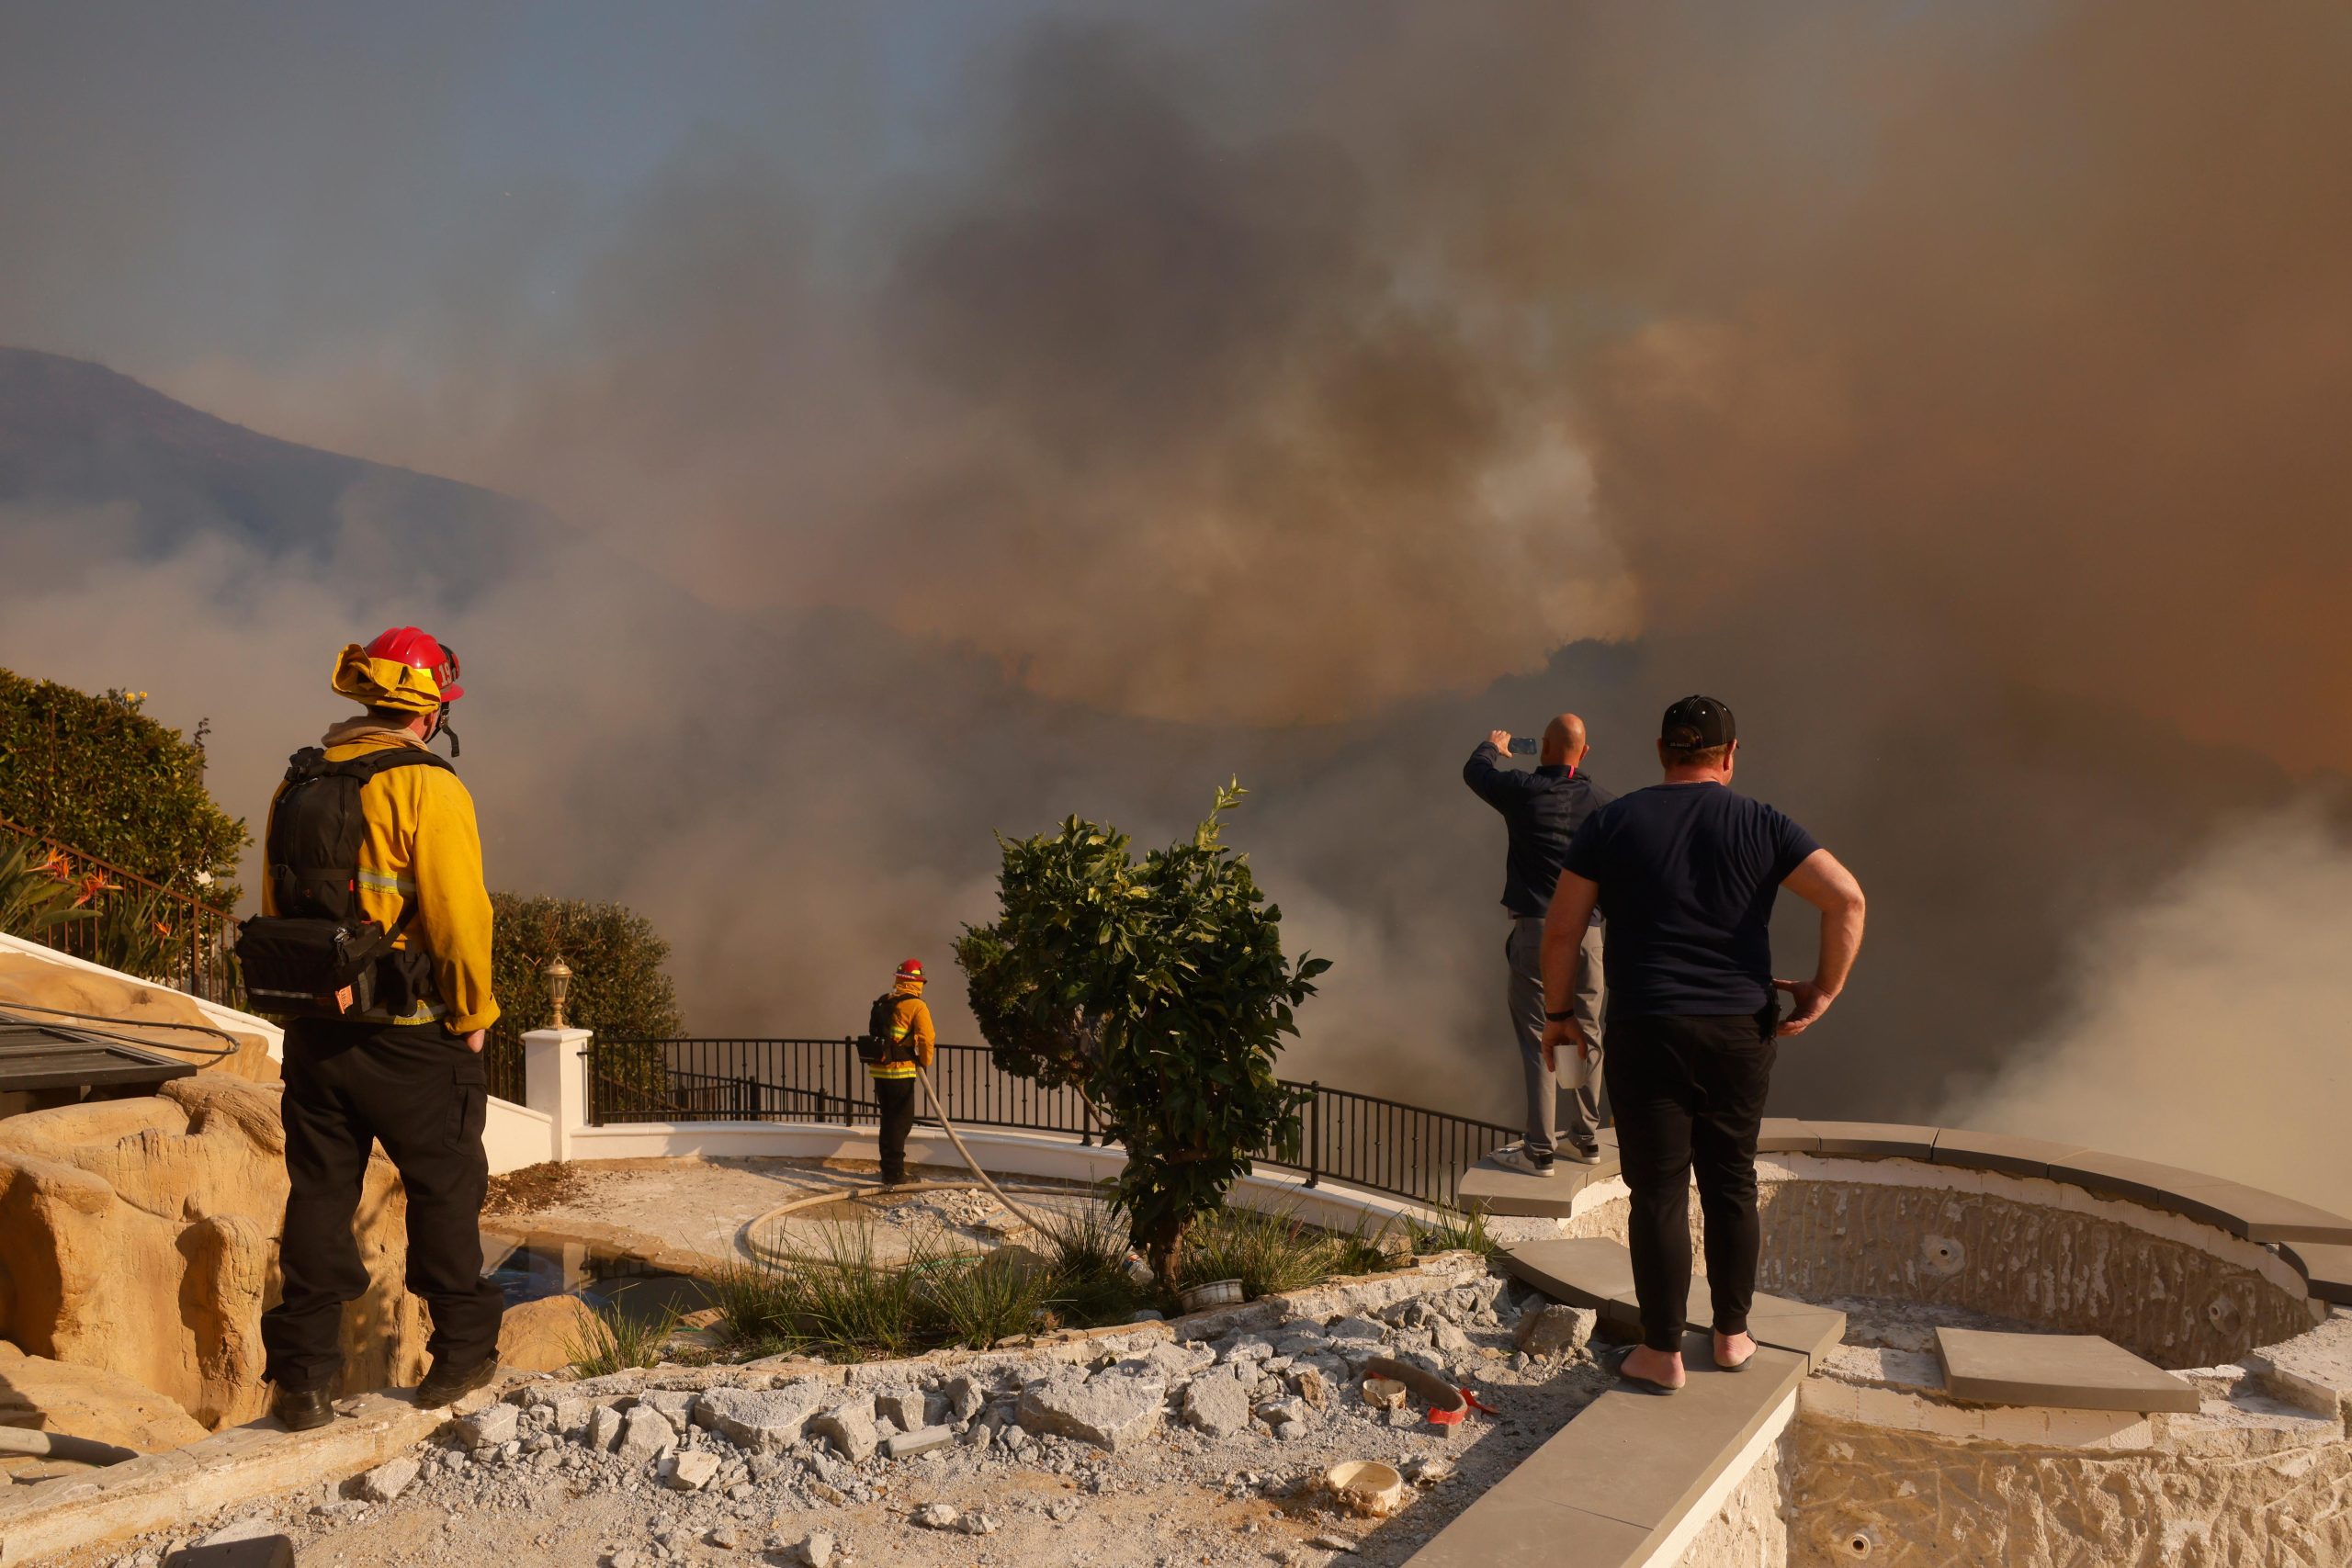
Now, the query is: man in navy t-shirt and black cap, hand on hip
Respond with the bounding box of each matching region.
[1543,696,1863,1394]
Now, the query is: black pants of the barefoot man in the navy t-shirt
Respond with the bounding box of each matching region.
[1606,1016,1776,1349]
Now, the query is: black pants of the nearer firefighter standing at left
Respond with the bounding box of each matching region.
[261,1018,505,1389]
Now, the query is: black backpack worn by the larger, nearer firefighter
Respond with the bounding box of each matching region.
[238,745,454,1018]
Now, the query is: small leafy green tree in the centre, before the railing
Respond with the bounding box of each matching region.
[957,783,1329,1288]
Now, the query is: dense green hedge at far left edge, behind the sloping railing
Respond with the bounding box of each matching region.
[0,670,241,908]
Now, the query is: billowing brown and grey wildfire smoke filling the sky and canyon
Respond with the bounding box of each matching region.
[0,5,2352,1203]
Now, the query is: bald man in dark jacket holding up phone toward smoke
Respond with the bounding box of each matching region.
[1463,712,1609,1176]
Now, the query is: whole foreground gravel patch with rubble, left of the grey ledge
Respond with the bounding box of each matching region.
[68,1277,1604,1568]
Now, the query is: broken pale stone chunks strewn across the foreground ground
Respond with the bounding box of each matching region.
[106,1259,1543,1568]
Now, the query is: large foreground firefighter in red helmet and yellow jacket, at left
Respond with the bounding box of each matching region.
[253,627,503,1429]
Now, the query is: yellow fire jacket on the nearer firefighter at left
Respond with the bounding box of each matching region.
[261,717,499,1034]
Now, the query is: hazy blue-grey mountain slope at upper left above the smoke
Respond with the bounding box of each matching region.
[0,348,548,600]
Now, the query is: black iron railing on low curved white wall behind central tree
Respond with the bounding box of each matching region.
[588,1039,1520,1206]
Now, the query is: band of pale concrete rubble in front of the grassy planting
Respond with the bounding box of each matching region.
[37,1260,1580,1568]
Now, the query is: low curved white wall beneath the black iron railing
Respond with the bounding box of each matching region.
[552,1122,1435,1232]
